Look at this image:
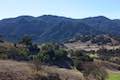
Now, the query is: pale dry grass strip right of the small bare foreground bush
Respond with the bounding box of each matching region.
[43,66,84,80]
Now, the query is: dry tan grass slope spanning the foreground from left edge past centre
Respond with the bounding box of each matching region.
[0,60,84,80]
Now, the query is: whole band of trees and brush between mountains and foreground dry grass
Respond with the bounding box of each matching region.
[0,37,120,80]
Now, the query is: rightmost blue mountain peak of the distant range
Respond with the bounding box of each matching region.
[80,16,120,35]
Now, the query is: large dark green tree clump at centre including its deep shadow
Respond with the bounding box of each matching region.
[32,44,73,68]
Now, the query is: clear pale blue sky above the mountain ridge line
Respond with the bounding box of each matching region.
[0,0,120,19]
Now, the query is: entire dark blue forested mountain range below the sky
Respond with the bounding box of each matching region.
[0,15,120,42]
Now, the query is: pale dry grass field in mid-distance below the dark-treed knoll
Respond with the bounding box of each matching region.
[65,41,120,51]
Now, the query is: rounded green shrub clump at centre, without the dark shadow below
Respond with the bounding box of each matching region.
[37,44,67,62]
